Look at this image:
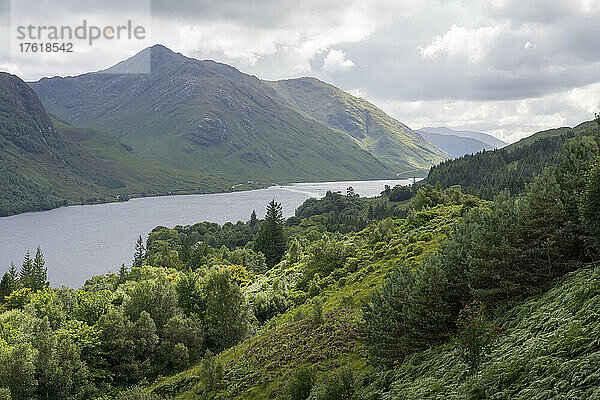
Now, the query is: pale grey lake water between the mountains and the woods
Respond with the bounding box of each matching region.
[0,179,412,287]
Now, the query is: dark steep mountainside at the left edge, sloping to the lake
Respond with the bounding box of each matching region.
[0,73,232,216]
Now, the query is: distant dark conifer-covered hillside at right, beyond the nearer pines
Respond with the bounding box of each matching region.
[423,121,595,199]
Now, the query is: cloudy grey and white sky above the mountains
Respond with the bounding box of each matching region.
[0,0,600,142]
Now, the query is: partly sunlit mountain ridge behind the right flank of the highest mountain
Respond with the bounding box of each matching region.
[269,78,448,172]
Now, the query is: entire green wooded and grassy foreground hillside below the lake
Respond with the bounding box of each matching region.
[0,132,600,400]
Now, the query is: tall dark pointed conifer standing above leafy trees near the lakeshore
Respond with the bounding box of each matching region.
[254,200,286,268]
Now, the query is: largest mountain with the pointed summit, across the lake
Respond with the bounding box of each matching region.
[30,45,442,182]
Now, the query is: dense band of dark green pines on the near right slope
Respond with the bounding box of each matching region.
[363,138,600,368]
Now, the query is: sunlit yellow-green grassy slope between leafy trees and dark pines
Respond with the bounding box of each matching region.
[152,206,460,400]
